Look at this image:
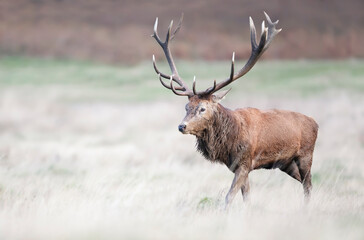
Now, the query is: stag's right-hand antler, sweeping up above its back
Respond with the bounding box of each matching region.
[199,12,282,95]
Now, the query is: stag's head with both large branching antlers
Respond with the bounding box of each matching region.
[152,12,281,136]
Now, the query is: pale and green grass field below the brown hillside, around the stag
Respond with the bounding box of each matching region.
[0,57,364,240]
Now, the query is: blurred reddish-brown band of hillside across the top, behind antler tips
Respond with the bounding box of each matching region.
[0,0,364,63]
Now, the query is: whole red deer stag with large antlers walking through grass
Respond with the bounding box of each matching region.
[152,12,318,206]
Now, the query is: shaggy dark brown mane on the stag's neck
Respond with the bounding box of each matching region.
[196,104,239,164]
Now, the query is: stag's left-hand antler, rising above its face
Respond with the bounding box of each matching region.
[152,14,194,96]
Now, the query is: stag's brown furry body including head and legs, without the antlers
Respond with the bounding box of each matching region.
[183,96,318,204]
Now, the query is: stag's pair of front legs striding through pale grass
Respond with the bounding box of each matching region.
[225,167,249,208]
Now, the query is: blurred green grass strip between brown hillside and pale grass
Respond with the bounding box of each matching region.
[0,57,364,101]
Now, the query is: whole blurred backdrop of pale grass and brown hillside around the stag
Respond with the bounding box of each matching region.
[0,0,364,240]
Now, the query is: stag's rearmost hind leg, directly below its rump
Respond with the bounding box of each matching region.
[297,154,312,202]
